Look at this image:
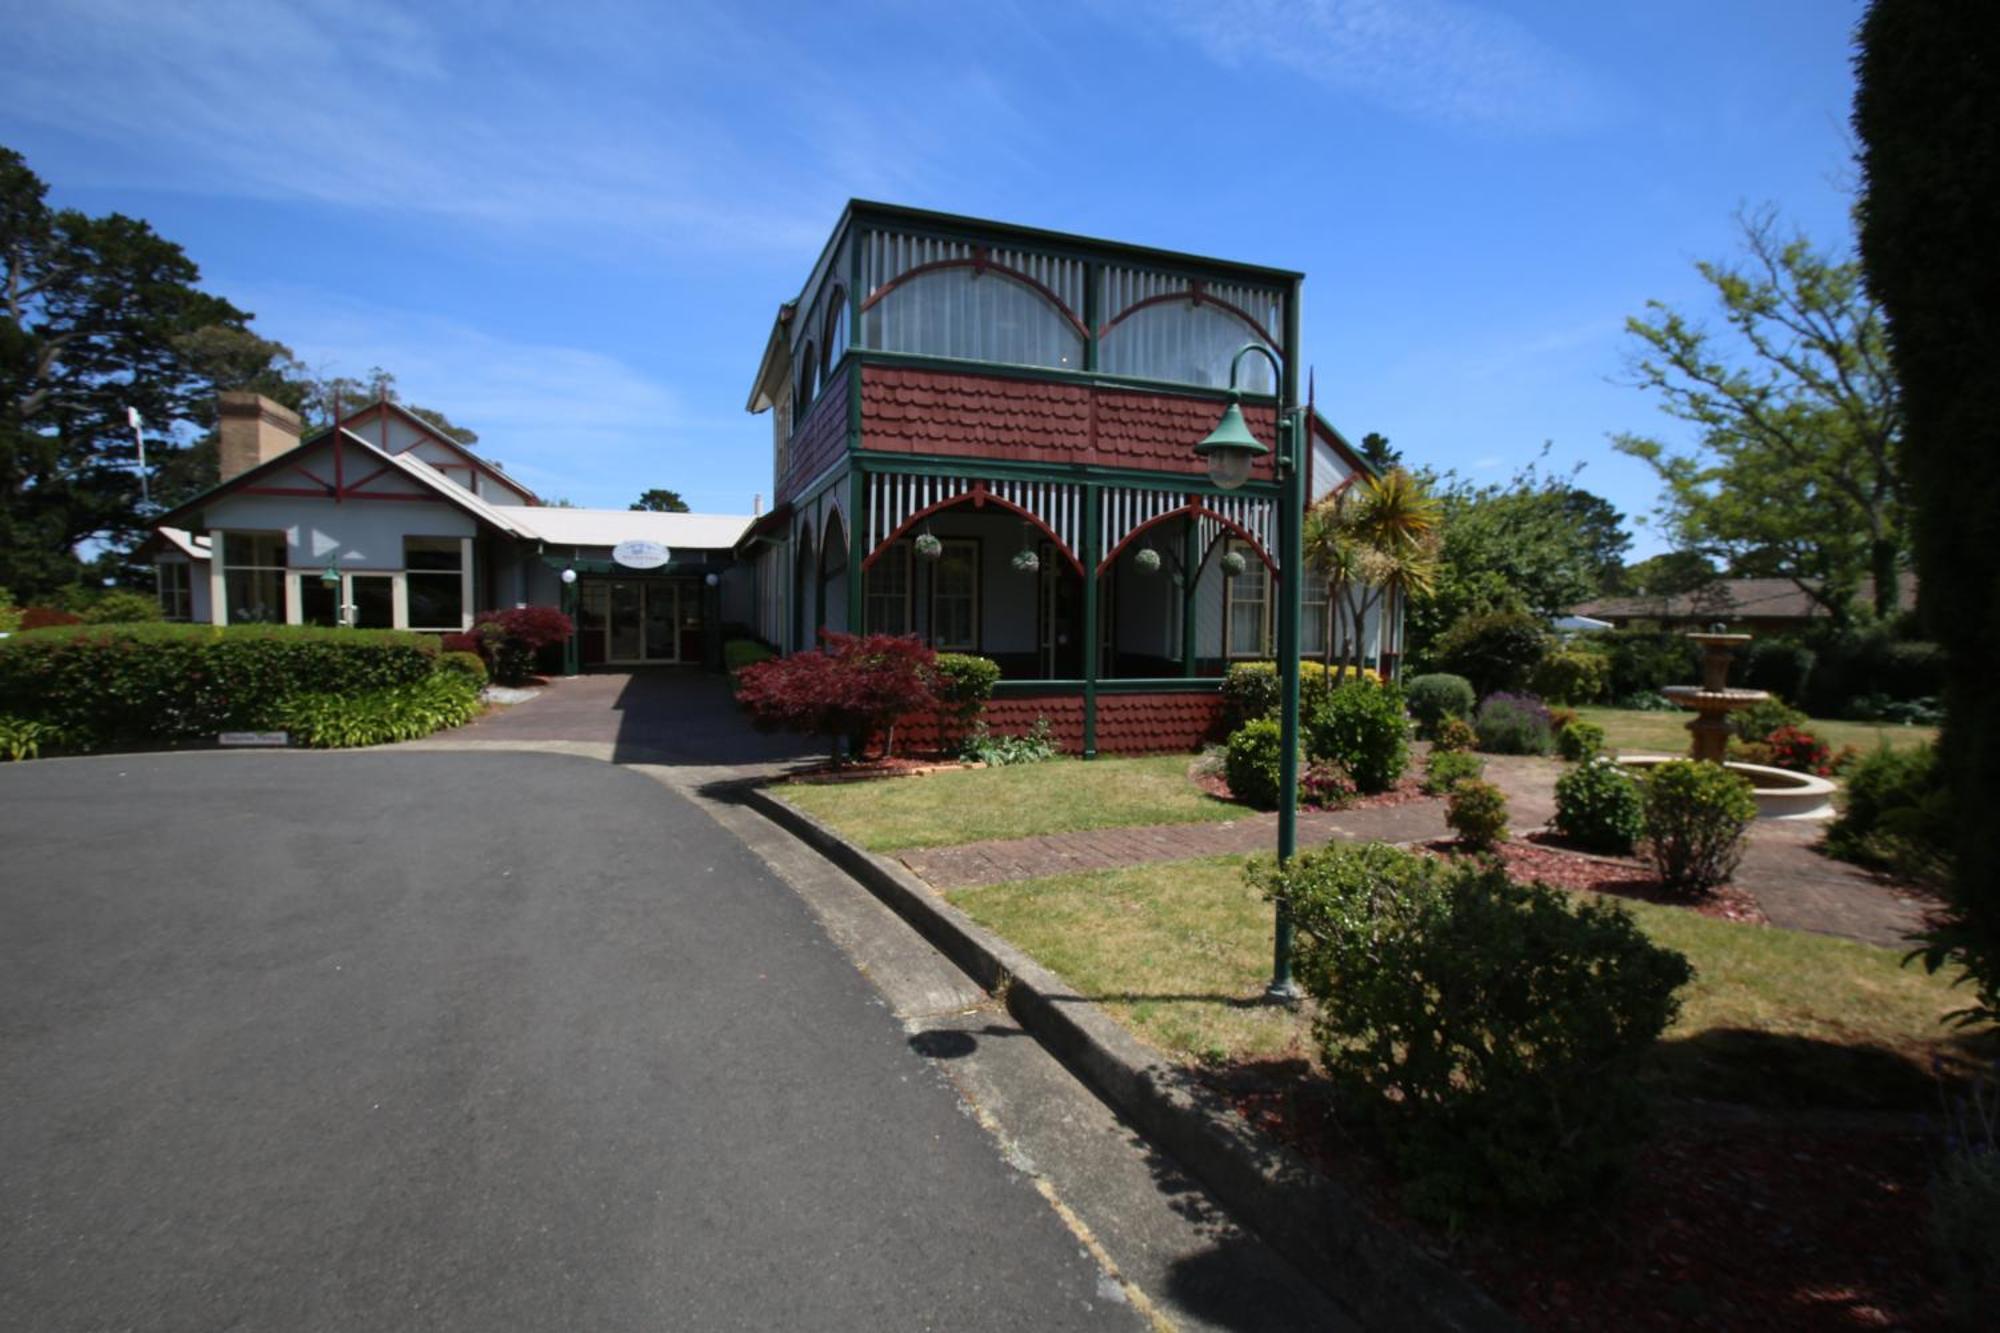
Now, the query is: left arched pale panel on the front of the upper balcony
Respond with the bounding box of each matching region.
[862,266,1084,370]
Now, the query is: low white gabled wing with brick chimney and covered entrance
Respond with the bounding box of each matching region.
[146,394,752,667]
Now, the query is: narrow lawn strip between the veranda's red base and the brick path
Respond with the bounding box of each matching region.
[774,755,1248,851]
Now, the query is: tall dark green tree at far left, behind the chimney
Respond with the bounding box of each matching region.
[0,148,270,600]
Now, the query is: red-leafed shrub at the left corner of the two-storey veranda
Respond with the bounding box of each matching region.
[736,630,938,763]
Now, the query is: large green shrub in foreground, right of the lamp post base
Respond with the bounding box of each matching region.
[1250,843,1692,1225]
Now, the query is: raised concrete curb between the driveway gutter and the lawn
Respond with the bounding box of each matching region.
[740,785,1522,1329]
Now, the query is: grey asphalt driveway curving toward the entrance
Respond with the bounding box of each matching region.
[0,753,1138,1331]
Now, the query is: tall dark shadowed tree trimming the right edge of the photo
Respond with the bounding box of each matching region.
[1854,0,2000,1021]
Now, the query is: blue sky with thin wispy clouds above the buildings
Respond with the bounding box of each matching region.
[0,0,1860,552]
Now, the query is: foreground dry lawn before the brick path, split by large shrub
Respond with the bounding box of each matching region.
[950,857,1962,1109]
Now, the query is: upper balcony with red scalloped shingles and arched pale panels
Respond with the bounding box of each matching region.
[750,200,1302,502]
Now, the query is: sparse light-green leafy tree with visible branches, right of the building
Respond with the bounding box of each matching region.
[1614,210,1908,622]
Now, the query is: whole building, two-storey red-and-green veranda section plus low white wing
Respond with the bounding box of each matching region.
[150,200,1396,753]
